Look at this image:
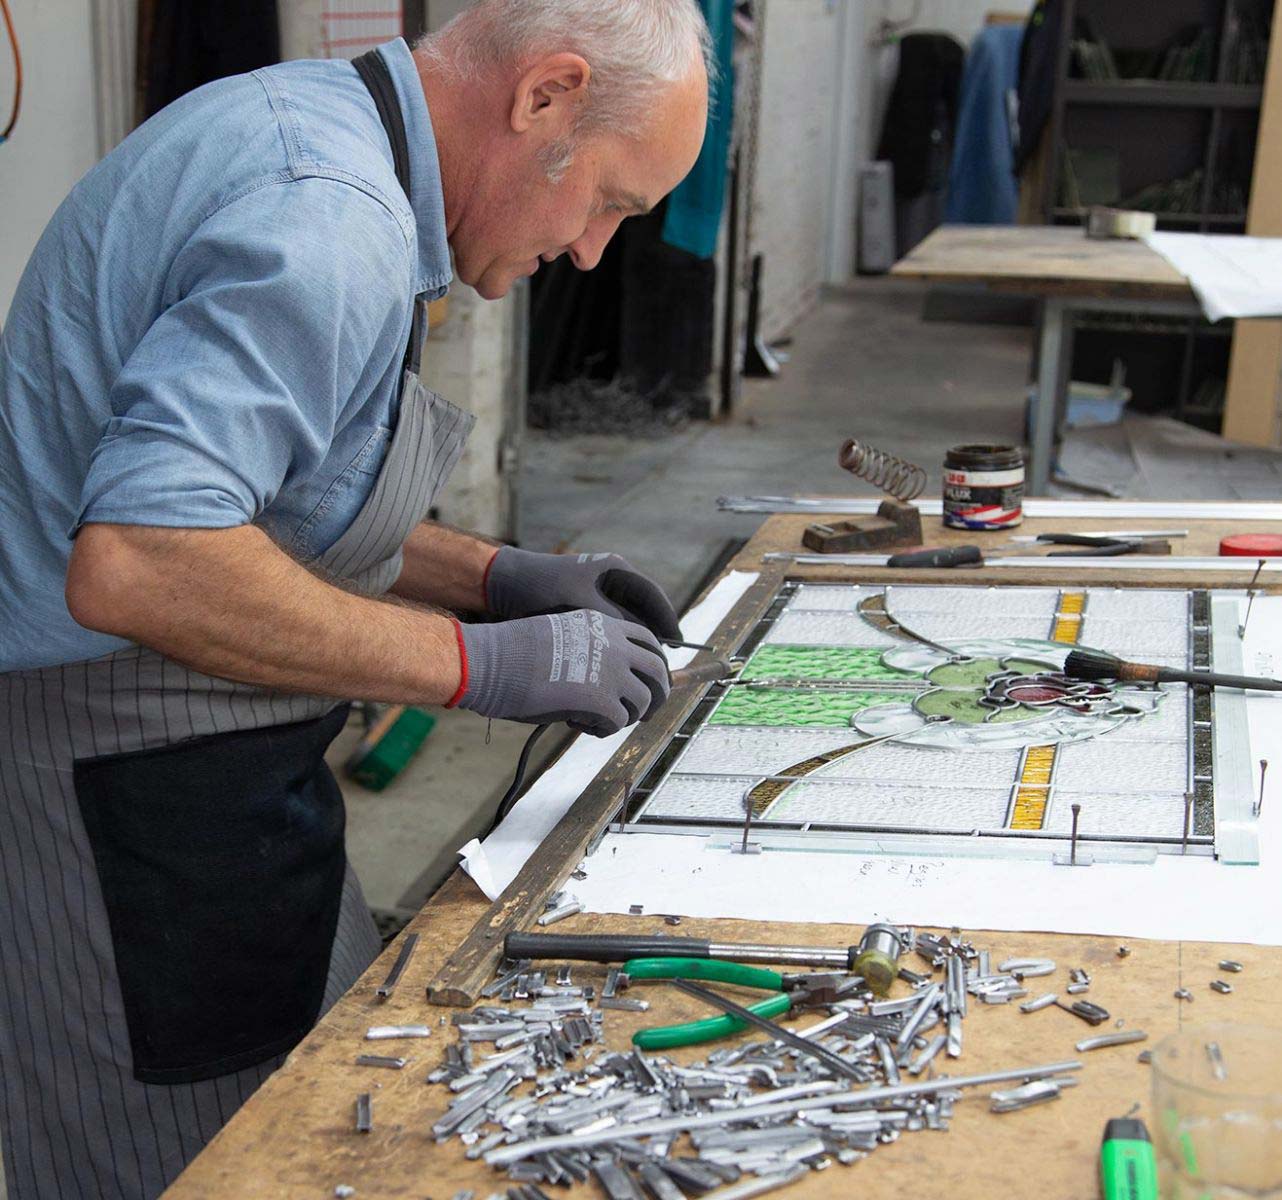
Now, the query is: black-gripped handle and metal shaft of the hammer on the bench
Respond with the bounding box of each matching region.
[503,933,859,971]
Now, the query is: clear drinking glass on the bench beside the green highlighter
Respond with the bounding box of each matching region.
[1150,1024,1282,1200]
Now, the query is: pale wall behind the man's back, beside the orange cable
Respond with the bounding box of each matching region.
[0,0,97,322]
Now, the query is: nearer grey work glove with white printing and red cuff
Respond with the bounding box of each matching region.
[458,609,670,737]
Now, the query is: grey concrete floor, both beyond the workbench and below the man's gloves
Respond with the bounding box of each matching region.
[331,279,1031,915]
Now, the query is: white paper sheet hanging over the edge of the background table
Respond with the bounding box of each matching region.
[1145,233,1282,321]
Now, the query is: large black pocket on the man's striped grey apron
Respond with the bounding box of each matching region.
[73,705,347,1083]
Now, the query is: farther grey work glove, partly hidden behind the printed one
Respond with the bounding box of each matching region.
[486,546,681,641]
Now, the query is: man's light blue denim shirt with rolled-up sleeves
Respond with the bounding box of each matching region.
[0,40,450,671]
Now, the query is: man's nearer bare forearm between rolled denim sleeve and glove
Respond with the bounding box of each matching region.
[67,524,460,704]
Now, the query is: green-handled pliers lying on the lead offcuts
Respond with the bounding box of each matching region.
[623,958,845,1050]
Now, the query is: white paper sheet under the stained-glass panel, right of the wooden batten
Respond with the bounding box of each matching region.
[574,596,1282,945]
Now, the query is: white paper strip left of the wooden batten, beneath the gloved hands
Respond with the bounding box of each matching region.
[459,571,756,900]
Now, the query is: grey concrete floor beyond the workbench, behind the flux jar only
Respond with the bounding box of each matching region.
[520,278,1031,599]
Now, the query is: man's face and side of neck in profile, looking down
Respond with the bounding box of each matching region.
[451,69,708,300]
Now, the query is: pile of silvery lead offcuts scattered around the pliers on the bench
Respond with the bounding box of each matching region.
[428,929,1144,1200]
